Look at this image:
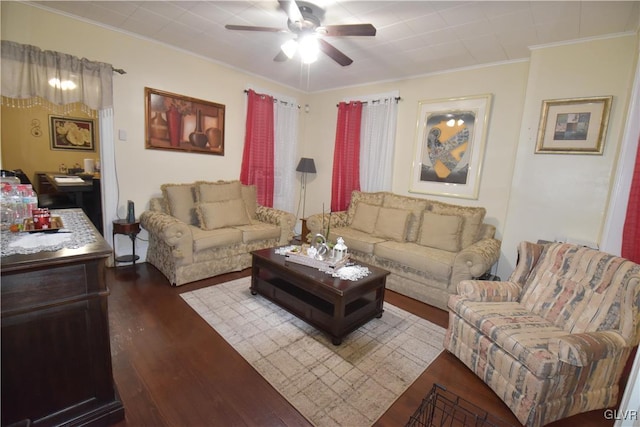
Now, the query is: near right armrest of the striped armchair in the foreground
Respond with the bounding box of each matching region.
[548,331,630,366]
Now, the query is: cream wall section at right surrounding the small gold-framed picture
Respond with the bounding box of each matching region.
[499,35,638,275]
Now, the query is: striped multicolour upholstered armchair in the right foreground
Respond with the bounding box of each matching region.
[445,242,640,427]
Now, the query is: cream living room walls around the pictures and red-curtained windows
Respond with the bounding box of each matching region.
[1,2,638,276]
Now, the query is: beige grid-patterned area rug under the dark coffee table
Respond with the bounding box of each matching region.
[181,277,444,427]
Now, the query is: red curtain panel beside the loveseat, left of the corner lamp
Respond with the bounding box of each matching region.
[240,90,274,207]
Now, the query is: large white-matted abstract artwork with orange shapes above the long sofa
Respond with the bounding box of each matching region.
[409,94,493,199]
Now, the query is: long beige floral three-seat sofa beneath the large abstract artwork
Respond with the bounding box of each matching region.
[307,191,501,310]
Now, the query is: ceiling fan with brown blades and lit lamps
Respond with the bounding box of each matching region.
[225,0,376,67]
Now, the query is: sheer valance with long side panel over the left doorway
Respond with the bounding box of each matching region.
[1,40,118,252]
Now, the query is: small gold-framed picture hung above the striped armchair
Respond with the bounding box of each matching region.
[535,96,613,155]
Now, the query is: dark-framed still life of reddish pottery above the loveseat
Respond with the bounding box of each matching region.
[144,87,225,156]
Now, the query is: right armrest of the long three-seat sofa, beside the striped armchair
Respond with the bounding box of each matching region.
[449,239,502,291]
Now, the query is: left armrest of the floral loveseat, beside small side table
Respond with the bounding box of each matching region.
[140,211,193,264]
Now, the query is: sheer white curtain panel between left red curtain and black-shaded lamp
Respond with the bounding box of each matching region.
[273,96,299,212]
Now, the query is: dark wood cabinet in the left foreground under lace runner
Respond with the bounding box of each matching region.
[0,216,124,426]
